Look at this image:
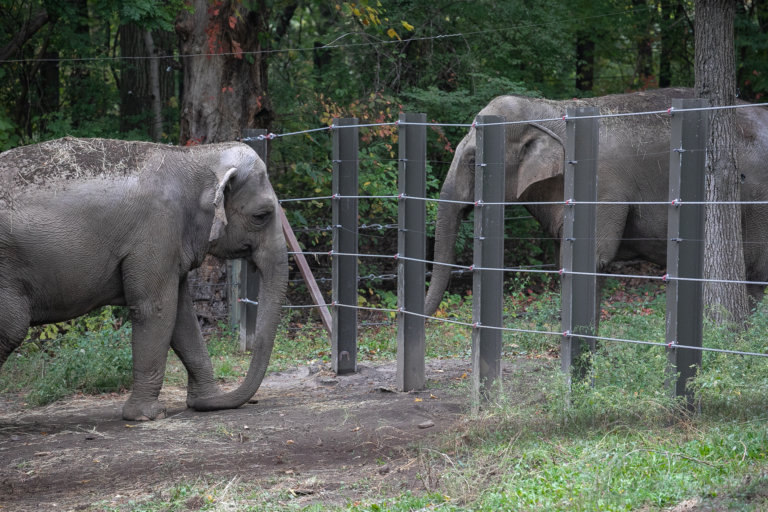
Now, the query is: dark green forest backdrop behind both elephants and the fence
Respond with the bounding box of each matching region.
[0,0,768,312]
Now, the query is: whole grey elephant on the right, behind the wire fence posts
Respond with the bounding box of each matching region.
[425,89,768,315]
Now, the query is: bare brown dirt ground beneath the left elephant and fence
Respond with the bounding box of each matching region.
[0,358,543,512]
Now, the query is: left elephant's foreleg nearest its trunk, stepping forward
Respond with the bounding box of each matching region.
[171,277,220,404]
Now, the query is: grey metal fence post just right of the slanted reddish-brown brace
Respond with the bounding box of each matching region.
[331,118,359,374]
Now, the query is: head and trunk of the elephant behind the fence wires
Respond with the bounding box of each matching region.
[424,96,565,315]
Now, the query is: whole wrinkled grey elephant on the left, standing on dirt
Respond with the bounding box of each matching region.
[0,138,288,420]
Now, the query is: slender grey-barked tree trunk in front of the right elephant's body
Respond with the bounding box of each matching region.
[695,0,749,327]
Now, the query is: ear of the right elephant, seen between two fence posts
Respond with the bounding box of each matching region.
[516,124,565,198]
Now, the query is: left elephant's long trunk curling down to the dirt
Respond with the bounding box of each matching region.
[194,246,288,411]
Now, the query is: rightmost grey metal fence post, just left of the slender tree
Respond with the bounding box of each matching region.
[666,99,709,408]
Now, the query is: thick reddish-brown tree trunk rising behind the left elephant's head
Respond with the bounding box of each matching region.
[176,0,274,144]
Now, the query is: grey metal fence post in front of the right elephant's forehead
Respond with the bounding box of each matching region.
[472,116,506,407]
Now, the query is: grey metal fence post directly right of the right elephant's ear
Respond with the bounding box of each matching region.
[560,107,600,384]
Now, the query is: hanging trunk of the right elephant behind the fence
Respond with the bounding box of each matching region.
[424,199,465,316]
